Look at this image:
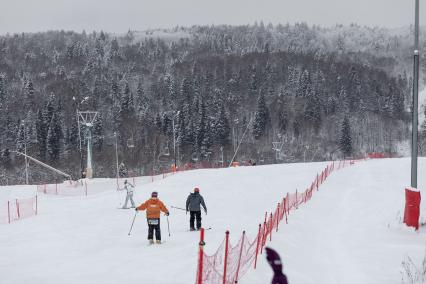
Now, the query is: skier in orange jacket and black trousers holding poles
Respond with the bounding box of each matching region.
[136,191,169,244]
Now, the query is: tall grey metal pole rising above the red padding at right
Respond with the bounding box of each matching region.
[411,0,419,188]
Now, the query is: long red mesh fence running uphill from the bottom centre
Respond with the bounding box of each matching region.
[196,159,364,284]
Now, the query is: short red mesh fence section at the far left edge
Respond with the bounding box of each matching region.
[0,196,38,224]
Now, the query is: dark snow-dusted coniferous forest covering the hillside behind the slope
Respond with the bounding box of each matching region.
[0,23,424,184]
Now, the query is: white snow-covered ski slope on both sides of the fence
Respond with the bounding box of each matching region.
[0,159,426,284]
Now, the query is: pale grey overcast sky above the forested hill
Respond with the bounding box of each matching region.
[0,0,426,34]
